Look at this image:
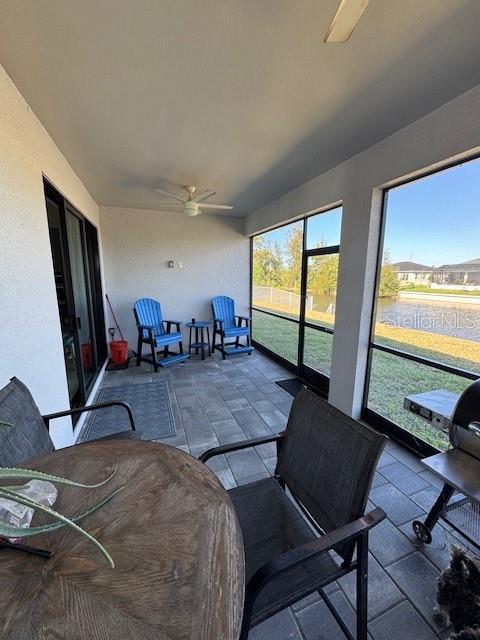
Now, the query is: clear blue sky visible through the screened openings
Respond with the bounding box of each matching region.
[258,158,480,266]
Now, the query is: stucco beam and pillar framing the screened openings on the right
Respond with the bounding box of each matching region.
[245,87,480,417]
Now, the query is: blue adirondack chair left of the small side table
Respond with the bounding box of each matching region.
[133,298,189,371]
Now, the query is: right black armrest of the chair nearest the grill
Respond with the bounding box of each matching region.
[247,507,386,598]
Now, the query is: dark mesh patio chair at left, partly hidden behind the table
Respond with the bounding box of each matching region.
[0,378,140,467]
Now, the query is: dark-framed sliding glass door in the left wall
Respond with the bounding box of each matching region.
[45,182,106,406]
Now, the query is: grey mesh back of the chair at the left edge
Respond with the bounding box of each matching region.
[0,378,54,467]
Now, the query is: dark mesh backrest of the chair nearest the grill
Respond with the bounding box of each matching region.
[276,387,386,533]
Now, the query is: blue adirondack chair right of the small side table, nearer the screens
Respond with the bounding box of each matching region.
[212,296,253,360]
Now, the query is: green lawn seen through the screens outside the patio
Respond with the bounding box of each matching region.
[253,311,470,449]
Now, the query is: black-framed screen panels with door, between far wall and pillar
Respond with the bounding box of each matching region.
[252,207,341,392]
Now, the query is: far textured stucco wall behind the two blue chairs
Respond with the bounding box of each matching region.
[100,207,250,348]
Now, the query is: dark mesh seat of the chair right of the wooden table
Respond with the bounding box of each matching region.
[229,478,338,626]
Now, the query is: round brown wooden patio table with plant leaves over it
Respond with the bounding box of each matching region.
[0,440,244,640]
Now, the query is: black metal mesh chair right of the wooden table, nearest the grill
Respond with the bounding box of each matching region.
[200,387,386,640]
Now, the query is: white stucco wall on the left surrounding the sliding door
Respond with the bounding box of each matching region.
[0,67,98,446]
